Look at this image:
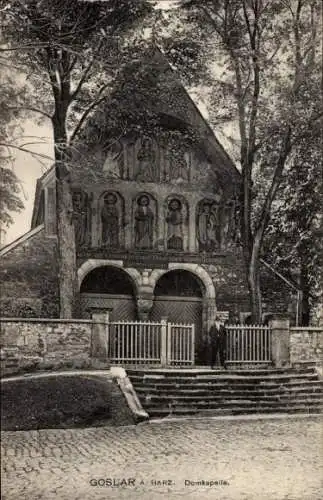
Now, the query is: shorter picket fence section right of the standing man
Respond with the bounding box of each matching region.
[226,325,271,364]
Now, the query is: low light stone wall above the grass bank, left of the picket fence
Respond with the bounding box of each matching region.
[0,318,105,373]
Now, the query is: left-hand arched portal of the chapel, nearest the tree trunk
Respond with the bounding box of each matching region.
[80,266,136,321]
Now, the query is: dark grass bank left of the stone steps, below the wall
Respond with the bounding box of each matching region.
[1,374,120,431]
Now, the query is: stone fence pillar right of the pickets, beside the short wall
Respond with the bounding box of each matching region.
[269,318,290,368]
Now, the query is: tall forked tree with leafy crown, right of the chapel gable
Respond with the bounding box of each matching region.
[175,0,321,321]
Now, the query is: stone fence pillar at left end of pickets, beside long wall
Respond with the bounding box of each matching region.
[91,312,109,363]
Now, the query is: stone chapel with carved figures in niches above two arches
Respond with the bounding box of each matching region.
[0,50,300,348]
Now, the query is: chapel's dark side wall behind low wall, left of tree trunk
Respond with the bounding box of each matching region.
[0,229,59,318]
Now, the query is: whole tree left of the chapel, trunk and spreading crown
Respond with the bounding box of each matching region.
[2,0,151,318]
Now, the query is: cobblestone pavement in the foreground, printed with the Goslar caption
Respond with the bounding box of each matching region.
[1,417,323,500]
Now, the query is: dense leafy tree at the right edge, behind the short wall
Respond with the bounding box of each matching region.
[264,133,323,325]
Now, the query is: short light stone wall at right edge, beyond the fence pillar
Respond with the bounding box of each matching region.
[289,327,323,369]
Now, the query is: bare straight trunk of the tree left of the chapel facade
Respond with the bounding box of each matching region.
[53,110,79,318]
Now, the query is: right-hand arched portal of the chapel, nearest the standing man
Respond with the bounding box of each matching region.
[151,269,206,360]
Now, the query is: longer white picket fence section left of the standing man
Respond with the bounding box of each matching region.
[107,320,195,366]
